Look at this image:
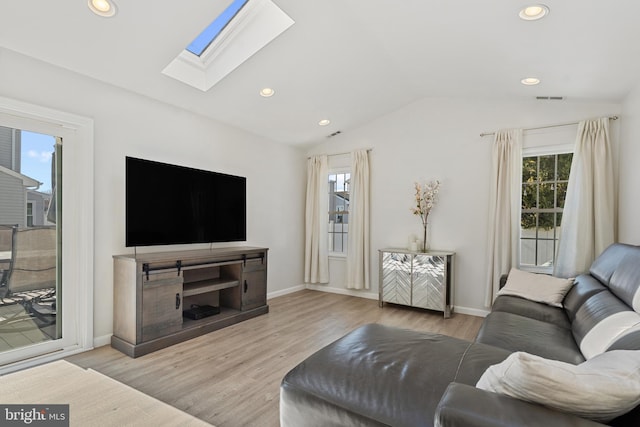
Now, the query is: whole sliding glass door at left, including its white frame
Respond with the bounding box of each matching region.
[0,97,94,375]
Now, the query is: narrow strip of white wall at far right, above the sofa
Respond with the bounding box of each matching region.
[618,85,640,245]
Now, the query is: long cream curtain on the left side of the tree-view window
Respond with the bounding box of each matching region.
[485,129,522,307]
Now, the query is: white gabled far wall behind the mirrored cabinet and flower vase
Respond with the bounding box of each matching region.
[307,98,620,314]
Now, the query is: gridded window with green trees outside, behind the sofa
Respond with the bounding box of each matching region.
[519,152,573,273]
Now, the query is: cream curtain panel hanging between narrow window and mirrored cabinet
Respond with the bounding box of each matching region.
[347,150,371,289]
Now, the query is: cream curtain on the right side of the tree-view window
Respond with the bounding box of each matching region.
[554,117,616,277]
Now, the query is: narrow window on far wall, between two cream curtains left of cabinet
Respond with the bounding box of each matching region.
[328,169,351,254]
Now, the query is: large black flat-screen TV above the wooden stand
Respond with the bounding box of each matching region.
[125,157,247,247]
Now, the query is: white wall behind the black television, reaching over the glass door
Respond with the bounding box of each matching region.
[0,49,306,338]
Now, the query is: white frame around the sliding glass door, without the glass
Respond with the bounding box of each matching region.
[0,97,94,375]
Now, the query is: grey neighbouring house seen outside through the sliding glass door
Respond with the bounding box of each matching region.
[0,126,51,227]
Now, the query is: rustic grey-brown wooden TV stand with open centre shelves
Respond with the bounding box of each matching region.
[111,246,269,357]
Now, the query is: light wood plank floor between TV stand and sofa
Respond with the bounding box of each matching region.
[67,290,482,427]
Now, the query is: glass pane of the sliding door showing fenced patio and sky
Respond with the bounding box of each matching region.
[0,126,64,361]
